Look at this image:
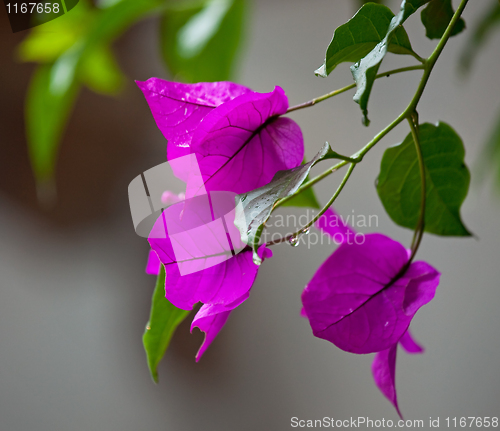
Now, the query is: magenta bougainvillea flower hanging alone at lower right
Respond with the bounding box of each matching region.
[302,211,440,414]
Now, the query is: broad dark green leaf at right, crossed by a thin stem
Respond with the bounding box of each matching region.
[377,123,470,236]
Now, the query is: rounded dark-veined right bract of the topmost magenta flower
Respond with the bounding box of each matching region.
[191,87,304,193]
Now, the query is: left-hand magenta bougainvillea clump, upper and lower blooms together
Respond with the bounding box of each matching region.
[137,78,304,360]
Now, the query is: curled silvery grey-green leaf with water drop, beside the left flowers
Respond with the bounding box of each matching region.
[234,142,336,265]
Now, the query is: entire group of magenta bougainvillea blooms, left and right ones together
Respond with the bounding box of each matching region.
[138,78,439,413]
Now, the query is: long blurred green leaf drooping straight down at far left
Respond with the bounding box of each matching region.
[26,62,79,187]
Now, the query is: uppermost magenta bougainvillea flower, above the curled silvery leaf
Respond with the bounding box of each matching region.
[137,78,304,193]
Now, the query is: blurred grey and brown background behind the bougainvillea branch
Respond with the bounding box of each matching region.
[0,0,500,431]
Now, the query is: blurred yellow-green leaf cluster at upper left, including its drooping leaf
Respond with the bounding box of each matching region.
[19,0,165,191]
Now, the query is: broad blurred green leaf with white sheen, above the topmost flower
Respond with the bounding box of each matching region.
[160,0,246,82]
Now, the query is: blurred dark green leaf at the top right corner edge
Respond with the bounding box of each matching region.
[460,2,500,72]
